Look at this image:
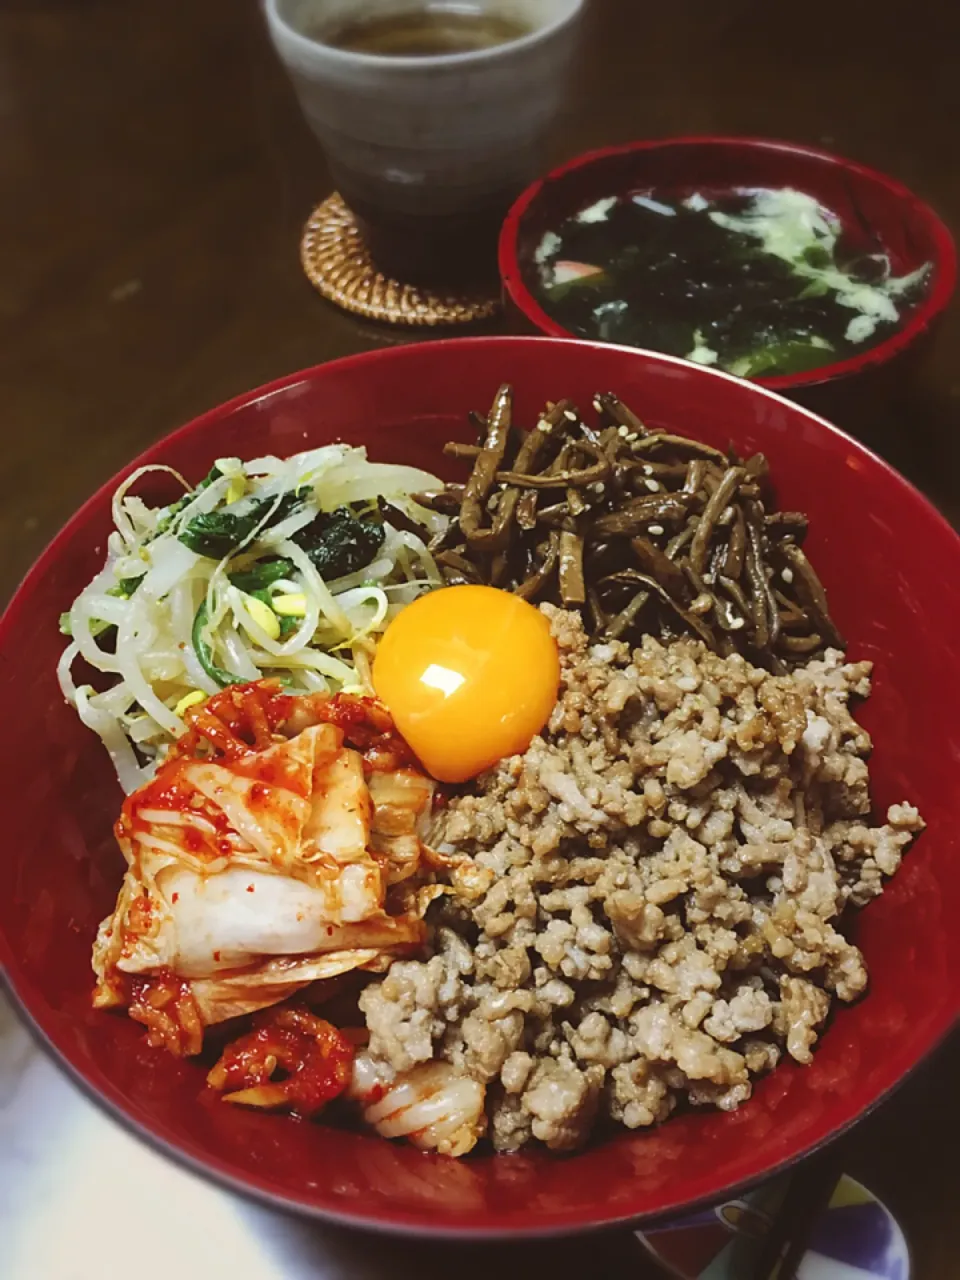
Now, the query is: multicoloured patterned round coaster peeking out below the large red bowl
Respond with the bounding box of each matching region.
[636,1175,910,1280]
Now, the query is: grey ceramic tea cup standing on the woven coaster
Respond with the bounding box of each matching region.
[264,0,585,283]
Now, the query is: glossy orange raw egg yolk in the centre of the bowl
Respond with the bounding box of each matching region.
[374,586,559,782]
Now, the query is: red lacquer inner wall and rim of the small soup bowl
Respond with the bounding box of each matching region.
[499,138,956,393]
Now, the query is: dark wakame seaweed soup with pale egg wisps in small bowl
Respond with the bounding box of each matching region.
[534,188,929,378]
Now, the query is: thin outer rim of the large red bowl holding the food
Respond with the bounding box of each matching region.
[0,334,960,1242]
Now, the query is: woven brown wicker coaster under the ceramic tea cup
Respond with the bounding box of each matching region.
[300,192,499,326]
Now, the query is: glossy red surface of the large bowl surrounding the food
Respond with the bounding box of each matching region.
[0,338,960,1235]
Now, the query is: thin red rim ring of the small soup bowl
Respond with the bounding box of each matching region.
[498,133,957,393]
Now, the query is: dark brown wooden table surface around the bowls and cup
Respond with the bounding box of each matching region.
[0,0,960,1280]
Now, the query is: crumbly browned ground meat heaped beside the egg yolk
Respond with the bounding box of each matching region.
[361,607,923,1151]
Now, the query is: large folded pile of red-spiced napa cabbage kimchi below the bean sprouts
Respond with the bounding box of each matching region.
[93,681,440,1055]
